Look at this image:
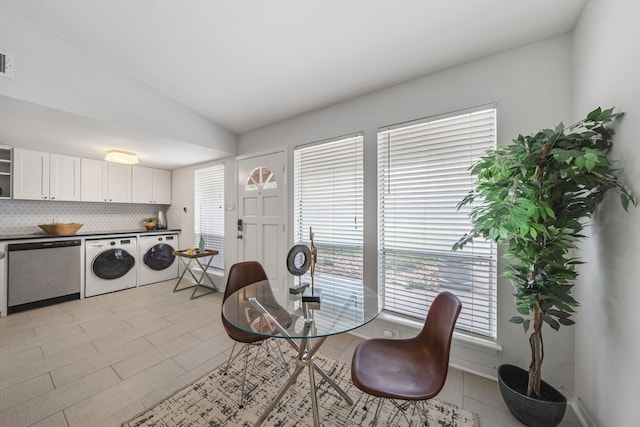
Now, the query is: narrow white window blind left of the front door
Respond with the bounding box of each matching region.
[193,164,224,269]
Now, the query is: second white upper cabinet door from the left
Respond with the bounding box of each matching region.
[49,154,80,200]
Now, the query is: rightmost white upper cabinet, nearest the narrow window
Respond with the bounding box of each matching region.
[131,166,171,205]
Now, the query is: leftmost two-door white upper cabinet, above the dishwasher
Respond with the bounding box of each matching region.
[13,148,80,200]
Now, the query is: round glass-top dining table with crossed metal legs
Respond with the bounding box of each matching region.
[222,275,382,426]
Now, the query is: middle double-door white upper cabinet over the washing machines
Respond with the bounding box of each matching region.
[80,159,131,203]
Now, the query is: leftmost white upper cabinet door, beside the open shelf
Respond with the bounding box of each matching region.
[13,148,49,200]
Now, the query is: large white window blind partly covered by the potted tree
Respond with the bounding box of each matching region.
[378,107,497,338]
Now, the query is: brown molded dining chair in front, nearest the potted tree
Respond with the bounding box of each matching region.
[351,292,462,425]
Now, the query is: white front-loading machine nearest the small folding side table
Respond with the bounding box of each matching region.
[138,233,180,285]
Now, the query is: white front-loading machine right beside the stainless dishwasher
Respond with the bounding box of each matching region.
[84,236,138,297]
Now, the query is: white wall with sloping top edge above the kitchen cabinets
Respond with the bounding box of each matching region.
[0,6,236,154]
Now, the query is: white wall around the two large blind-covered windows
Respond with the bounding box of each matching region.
[239,35,573,390]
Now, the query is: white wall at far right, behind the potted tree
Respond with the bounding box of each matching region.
[573,0,640,426]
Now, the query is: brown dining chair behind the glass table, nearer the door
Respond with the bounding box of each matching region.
[222,261,287,408]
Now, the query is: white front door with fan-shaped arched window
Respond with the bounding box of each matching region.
[238,151,287,277]
